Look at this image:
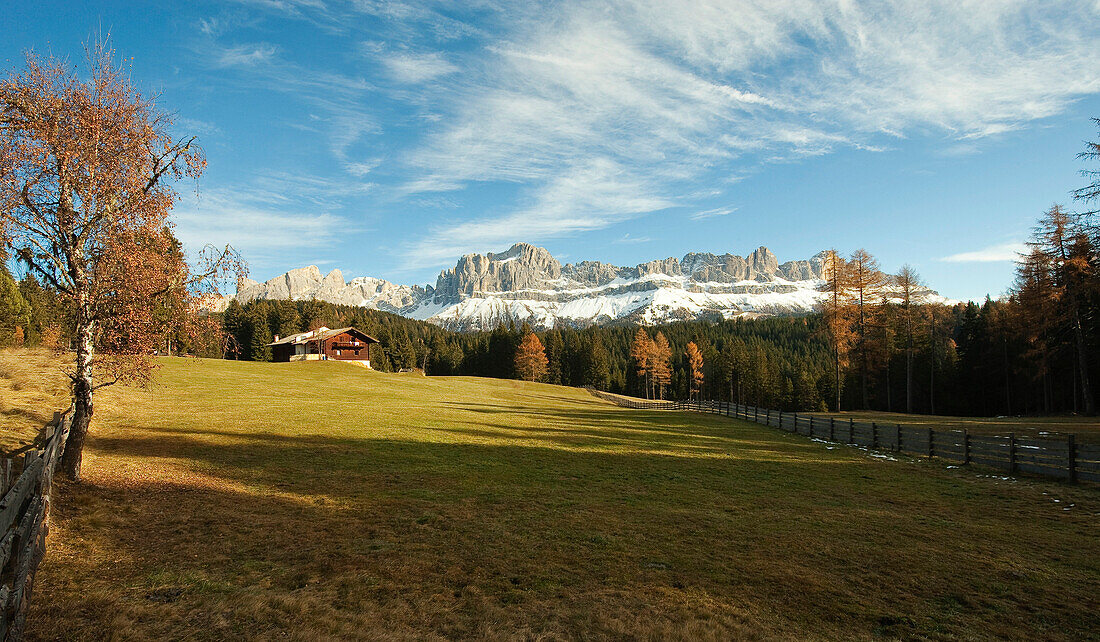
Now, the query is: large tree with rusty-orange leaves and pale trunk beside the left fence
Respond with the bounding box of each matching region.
[0,45,234,479]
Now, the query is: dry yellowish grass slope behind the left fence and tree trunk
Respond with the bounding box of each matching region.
[0,348,69,456]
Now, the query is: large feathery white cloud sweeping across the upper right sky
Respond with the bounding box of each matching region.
[187,0,1100,278]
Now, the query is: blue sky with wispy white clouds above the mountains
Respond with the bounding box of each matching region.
[0,0,1100,299]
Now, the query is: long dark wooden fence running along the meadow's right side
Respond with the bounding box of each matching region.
[592,390,1100,483]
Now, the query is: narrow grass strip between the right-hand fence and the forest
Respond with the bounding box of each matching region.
[811,410,1100,442]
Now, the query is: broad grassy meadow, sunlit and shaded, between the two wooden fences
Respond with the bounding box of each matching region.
[21,358,1100,641]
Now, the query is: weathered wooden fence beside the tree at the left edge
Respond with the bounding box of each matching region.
[0,408,73,641]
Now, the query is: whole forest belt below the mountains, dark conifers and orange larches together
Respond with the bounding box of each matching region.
[0,121,1100,416]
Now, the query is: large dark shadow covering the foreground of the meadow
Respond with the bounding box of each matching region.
[32,422,1100,639]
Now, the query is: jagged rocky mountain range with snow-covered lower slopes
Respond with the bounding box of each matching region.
[229,243,937,330]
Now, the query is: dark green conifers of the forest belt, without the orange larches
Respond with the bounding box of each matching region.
[0,250,1086,416]
